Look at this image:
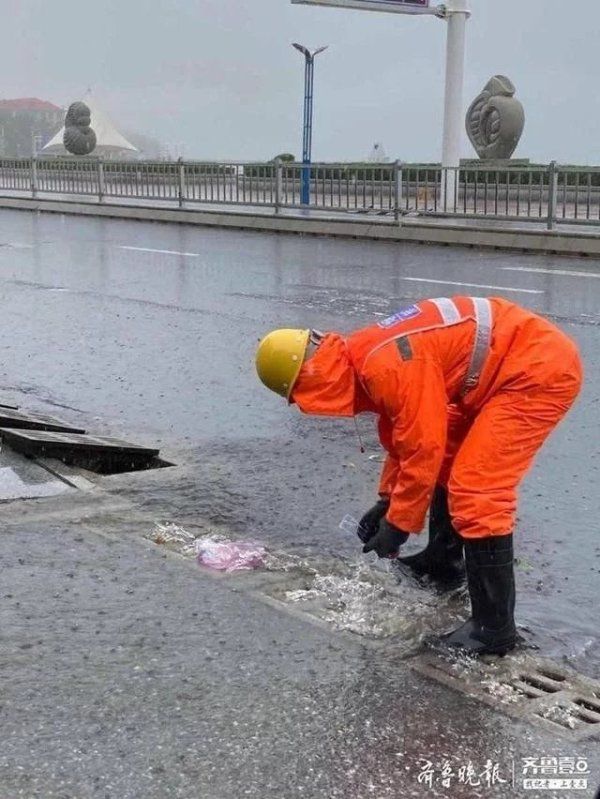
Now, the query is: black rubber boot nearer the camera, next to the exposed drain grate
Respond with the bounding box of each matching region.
[438,535,517,655]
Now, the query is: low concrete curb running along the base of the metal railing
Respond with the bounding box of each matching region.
[0,197,600,258]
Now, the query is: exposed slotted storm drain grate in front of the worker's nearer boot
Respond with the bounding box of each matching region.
[411,653,600,741]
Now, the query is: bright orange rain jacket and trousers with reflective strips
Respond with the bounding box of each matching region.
[291,297,582,538]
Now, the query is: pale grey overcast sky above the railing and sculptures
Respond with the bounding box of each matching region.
[0,0,600,164]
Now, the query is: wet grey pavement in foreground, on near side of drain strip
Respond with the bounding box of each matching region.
[0,462,600,799]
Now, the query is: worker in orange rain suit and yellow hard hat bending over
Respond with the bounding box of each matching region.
[256,297,582,654]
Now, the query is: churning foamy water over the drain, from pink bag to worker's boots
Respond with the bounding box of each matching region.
[145,524,463,658]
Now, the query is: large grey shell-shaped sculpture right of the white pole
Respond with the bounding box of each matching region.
[466,75,525,160]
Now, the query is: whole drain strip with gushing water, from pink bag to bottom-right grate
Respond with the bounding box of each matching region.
[146,524,600,741]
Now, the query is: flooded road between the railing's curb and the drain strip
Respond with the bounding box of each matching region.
[0,211,600,676]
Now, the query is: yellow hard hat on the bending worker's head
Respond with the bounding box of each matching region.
[256,328,310,400]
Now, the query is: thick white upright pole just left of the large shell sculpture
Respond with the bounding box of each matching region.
[441,0,471,210]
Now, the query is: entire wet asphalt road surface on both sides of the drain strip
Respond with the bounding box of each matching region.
[0,212,600,799]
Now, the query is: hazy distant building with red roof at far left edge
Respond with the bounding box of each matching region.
[0,97,65,158]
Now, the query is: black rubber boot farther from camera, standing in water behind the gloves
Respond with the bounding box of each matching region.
[398,485,465,583]
